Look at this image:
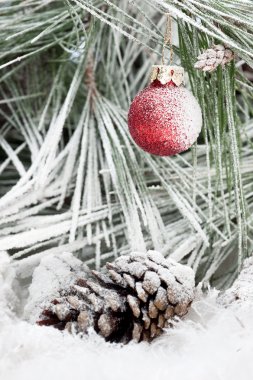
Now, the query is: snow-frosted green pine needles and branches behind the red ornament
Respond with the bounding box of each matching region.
[0,0,253,286]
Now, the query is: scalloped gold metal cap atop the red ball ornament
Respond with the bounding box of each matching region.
[150,65,184,86]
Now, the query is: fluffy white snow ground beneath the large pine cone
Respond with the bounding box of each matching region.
[0,249,253,380]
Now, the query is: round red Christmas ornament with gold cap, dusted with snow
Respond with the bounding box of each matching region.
[128,65,202,156]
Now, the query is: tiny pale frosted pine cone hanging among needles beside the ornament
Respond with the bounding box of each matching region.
[194,45,234,72]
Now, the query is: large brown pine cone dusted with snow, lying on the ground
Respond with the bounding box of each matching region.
[38,251,194,343]
